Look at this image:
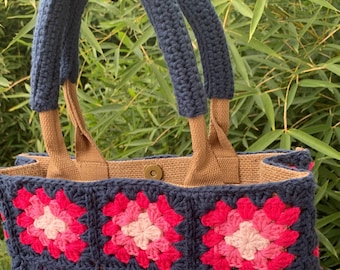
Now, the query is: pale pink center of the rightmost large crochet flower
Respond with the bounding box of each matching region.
[224,221,270,261]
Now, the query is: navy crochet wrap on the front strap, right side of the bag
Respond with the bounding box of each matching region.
[141,0,207,117]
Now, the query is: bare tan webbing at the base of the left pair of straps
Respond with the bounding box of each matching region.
[39,81,109,181]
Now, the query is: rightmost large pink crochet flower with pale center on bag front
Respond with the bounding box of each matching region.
[201,196,300,270]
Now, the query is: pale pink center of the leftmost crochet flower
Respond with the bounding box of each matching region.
[33,206,68,240]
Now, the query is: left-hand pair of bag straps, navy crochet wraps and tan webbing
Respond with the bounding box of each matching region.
[30,0,109,181]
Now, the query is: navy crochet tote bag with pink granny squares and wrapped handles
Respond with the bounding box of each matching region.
[0,0,319,270]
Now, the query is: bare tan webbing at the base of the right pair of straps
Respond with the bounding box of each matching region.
[184,99,240,186]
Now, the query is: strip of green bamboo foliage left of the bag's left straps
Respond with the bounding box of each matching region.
[0,0,38,166]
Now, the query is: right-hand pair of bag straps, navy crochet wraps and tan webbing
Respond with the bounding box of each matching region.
[141,0,240,186]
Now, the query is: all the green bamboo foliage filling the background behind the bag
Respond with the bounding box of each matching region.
[0,0,340,269]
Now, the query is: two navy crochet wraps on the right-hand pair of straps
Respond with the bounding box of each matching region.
[141,0,234,117]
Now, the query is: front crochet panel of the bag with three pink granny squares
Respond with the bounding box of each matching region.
[0,152,319,270]
